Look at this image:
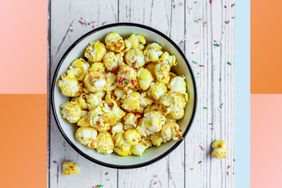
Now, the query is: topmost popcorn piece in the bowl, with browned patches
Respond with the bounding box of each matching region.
[105,32,125,52]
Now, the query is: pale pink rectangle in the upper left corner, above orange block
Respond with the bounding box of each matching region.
[0,0,47,93]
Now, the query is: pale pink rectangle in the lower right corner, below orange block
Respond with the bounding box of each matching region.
[251,94,282,188]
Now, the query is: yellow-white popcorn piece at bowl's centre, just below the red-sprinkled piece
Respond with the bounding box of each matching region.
[121,92,141,112]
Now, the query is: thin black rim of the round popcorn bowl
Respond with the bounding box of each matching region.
[50,22,197,169]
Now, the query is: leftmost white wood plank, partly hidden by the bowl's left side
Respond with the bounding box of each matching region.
[49,0,118,188]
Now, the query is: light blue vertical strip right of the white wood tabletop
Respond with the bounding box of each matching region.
[235,0,250,188]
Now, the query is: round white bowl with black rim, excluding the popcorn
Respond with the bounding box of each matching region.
[51,23,196,168]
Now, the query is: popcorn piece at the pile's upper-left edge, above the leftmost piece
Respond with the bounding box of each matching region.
[67,58,90,81]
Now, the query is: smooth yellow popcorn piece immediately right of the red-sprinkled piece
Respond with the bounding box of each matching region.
[137,68,154,90]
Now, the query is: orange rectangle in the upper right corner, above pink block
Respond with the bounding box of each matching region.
[251,0,282,93]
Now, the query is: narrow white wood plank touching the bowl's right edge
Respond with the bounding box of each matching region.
[185,0,209,188]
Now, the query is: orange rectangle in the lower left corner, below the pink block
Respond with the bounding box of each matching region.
[0,94,47,188]
